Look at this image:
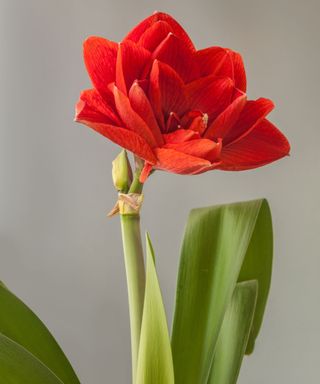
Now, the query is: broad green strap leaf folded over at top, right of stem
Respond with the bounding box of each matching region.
[172,200,272,384]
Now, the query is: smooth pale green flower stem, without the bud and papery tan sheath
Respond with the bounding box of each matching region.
[120,174,145,384]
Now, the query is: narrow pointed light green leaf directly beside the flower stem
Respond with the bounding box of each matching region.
[136,235,174,384]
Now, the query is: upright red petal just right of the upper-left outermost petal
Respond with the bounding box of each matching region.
[116,40,151,94]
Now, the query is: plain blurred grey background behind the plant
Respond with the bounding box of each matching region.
[0,0,320,384]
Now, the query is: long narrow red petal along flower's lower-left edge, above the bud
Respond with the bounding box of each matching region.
[75,120,156,164]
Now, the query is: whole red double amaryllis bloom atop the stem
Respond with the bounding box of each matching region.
[75,12,290,182]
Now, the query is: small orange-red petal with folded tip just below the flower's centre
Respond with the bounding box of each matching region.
[164,139,221,162]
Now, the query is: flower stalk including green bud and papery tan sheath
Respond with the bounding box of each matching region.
[109,150,145,383]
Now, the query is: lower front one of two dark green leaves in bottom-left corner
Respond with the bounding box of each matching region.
[0,333,63,384]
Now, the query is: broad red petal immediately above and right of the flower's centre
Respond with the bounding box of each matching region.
[186,76,234,124]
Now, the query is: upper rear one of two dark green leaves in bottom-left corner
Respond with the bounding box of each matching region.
[0,284,80,384]
